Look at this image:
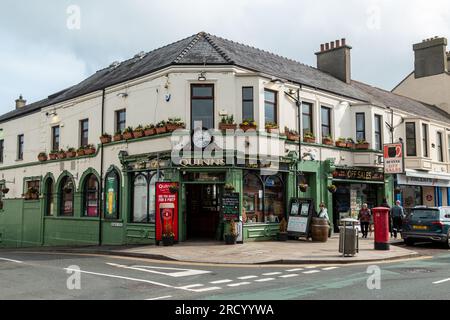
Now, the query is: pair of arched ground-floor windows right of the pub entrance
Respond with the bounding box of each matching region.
[243,173,285,223]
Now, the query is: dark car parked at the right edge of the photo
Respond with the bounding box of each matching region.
[402,207,450,249]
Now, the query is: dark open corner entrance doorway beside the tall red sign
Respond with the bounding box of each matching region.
[186,184,221,240]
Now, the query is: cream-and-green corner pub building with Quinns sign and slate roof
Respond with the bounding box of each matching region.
[0,32,450,247]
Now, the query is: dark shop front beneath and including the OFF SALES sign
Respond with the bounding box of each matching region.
[333,168,385,232]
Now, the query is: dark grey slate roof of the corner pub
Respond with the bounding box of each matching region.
[0,32,448,122]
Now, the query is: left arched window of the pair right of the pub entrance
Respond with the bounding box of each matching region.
[243,173,264,223]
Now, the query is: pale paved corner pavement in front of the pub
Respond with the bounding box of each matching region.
[9,236,421,265]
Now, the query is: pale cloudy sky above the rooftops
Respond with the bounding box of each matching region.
[0,0,450,113]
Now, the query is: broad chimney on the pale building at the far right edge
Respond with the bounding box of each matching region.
[413,37,448,79]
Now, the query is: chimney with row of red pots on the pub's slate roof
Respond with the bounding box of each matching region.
[316,39,352,83]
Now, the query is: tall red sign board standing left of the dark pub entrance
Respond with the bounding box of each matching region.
[156,182,178,241]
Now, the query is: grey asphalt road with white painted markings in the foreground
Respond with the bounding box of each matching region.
[0,245,450,300]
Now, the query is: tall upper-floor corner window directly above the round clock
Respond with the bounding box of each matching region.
[191,84,214,130]
